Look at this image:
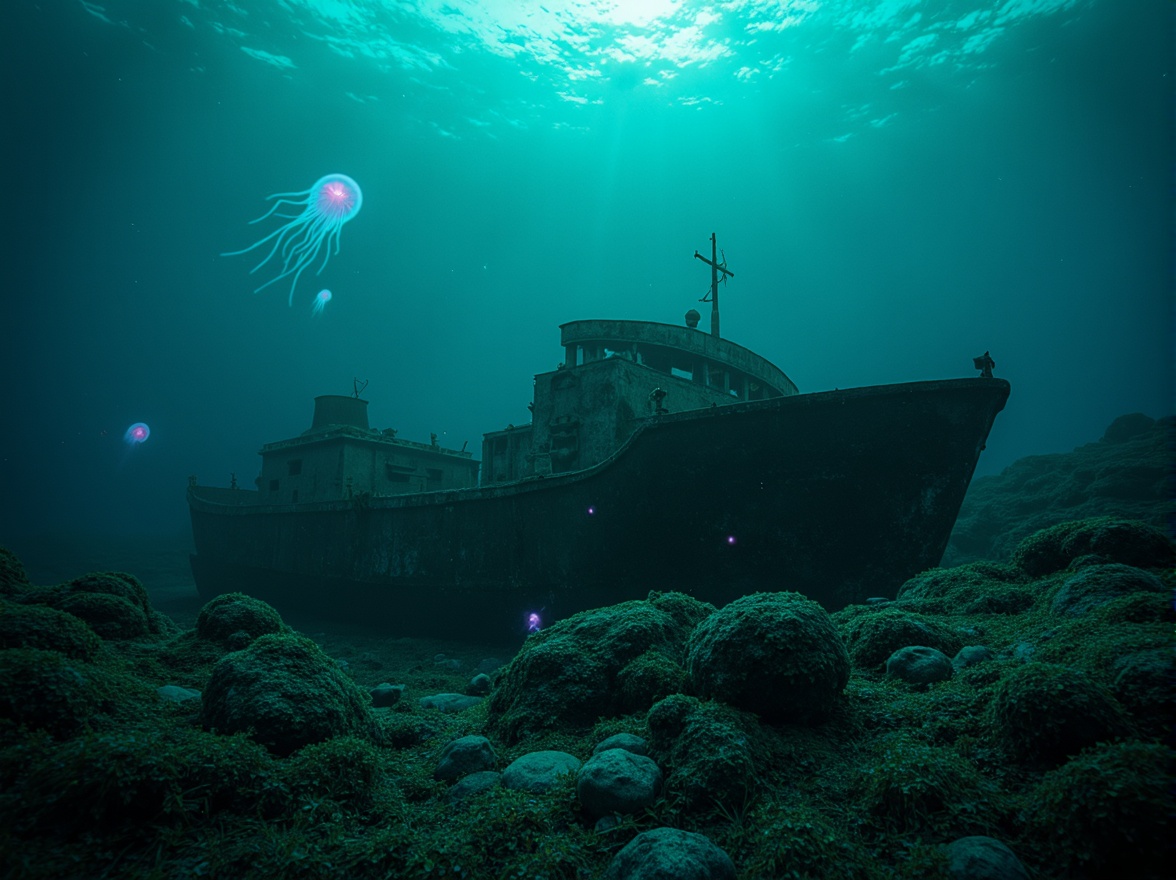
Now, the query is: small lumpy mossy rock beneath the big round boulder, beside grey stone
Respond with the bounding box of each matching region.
[647,694,759,811]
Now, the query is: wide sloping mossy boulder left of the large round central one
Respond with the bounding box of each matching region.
[487,593,714,742]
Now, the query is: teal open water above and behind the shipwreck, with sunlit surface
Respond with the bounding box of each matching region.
[0,0,1176,536]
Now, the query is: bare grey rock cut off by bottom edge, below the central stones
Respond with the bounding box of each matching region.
[604,828,735,880]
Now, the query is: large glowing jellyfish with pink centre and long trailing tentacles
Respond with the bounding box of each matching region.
[221,174,363,306]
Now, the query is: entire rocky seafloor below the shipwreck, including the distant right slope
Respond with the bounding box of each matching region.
[0,416,1176,880]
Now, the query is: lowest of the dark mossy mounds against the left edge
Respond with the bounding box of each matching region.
[0,648,107,739]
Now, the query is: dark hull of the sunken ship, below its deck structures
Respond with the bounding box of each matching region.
[188,379,1009,639]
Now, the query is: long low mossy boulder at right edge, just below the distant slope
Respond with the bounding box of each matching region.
[1013,516,1176,578]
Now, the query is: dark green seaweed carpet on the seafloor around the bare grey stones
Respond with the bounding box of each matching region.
[0,508,1176,878]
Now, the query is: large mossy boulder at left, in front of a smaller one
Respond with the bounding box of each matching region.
[201,633,375,755]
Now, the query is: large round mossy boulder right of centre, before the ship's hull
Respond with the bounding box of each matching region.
[687,593,849,724]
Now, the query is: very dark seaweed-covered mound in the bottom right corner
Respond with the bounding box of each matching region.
[1025,742,1176,880]
